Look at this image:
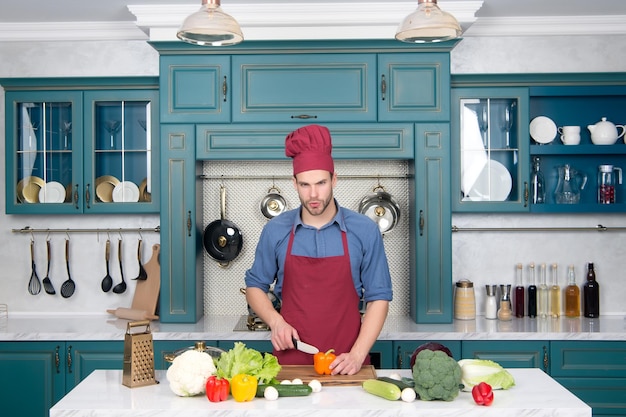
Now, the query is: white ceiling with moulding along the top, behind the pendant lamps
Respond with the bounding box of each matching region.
[0,0,626,41]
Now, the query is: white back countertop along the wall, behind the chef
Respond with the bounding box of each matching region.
[0,314,626,341]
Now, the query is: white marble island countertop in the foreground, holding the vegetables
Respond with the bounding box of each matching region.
[50,369,591,417]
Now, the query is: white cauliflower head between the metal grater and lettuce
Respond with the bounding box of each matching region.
[166,350,216,397]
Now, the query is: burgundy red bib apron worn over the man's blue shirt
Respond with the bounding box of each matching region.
[273,224,369,365]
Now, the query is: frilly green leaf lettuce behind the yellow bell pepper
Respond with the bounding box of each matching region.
[216,342,281,384]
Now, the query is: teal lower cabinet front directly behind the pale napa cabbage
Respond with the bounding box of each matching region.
[462,340,550,373]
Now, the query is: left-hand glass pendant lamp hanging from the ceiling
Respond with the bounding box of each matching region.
[176,0,243,46]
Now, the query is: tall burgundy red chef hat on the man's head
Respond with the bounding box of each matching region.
[285,125,335,175]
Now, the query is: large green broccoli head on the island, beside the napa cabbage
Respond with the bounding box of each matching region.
[413,349,461,401]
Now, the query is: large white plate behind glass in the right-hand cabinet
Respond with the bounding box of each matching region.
[467,160,513,201]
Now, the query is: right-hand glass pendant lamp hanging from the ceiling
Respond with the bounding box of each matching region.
[396,0,461,43]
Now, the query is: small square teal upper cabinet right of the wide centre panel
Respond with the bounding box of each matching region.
[378,52,450,122]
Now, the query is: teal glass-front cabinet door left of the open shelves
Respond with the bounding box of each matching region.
[451,88,529,211]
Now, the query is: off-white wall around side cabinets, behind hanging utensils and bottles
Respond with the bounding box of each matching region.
[0,36,626,314]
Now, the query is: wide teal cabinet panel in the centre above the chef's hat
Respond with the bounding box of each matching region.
[232,54,376,124]
